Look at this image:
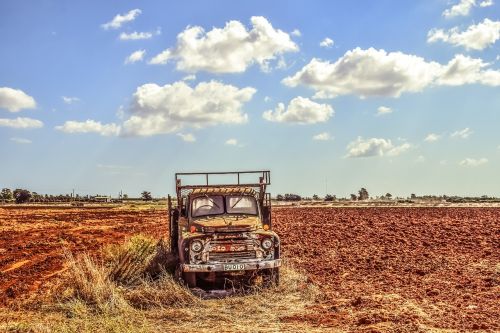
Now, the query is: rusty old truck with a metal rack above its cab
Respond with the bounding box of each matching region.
[169,171,281,290]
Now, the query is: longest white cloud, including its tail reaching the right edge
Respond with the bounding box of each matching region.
[282,48,500,98]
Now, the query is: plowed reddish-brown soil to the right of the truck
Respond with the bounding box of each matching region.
[274,208,500,329]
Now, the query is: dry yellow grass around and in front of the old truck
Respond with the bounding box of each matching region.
[0,236,320,333]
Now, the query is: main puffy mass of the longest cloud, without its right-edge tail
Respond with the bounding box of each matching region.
[283,48,440,98]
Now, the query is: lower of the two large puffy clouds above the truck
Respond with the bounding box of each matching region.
[122,81,256,136]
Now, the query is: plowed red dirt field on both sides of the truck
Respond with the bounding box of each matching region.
[0,207,500,332]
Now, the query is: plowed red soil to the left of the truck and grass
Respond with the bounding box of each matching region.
[0,208,166,305]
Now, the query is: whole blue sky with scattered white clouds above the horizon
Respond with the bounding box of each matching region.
[0,0,500,196]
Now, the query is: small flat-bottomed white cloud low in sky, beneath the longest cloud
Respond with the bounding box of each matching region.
[347,136,411,157]
